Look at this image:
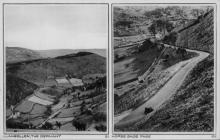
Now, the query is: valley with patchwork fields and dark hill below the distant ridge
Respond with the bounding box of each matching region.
[6,49,107,132]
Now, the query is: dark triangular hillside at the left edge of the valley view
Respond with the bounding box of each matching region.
[6,75,38,107]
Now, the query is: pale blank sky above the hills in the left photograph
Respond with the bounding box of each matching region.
[4,4,108,50]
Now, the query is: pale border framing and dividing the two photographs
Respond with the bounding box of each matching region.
[0,0,220,140]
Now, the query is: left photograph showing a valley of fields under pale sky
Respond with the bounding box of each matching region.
[4,4,108,132]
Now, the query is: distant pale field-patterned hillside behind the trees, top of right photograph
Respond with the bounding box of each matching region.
[113,6,207,37]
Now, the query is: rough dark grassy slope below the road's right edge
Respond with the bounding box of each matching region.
[124,56,214,132]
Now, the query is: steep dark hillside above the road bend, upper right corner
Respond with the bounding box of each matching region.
[176,10,214,54]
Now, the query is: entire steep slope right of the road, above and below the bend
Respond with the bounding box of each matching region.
[120,10,214,132]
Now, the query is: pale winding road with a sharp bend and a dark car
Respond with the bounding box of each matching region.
[115,49,209,127]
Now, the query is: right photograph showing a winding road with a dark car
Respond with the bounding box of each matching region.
[112,4,216,132]
